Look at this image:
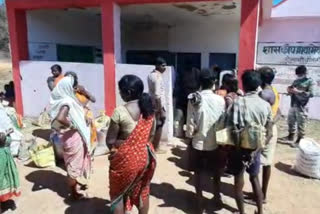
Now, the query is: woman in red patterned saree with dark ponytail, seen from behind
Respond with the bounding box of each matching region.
[107,75,159,214]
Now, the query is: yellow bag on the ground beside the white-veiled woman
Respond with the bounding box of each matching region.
[29,138,56,168]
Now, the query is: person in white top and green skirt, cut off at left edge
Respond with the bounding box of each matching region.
[0,104,20,214]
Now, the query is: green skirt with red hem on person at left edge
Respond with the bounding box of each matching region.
[0,130,20,214]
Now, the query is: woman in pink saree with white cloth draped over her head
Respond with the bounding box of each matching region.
[49,76,91,200]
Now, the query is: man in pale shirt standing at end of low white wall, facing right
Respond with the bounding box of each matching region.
[148,58,167,154]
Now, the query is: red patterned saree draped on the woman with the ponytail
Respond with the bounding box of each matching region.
[109,117,156,211]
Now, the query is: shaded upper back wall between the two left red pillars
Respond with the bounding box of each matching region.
[27,9,102,47]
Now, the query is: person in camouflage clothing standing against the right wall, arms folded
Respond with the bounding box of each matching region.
[285,65,314,146]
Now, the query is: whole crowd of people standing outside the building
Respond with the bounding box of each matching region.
[0,58,313,214]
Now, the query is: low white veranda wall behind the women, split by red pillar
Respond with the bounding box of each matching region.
[20,61,174,140]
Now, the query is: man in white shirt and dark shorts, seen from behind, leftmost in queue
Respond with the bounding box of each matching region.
[186,70,226,213]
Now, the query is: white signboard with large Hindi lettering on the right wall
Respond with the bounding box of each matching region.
[257,42,320,67]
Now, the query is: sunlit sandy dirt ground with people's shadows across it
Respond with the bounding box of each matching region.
[0,59,320,214]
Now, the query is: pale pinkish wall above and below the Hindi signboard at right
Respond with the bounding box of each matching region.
[257,17,320,119]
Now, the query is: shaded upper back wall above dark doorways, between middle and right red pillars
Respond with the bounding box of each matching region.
[169,21,240,67]
